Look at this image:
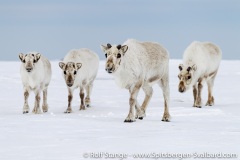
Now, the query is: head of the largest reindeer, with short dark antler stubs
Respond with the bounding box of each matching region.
[101,43,128,73]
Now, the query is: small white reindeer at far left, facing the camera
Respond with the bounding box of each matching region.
[19,52,52,114]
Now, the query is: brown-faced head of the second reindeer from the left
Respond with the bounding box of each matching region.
[59,62,82,87]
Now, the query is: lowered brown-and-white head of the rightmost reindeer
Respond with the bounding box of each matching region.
[178,64,197,93]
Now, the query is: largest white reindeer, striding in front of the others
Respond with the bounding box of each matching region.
[101,39,170,122]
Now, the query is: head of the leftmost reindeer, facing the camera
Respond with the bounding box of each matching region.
[19,53,41,73]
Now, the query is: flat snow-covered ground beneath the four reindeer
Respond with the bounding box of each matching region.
[0,60,240,160]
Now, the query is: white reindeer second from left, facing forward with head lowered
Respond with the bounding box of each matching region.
[59,49,99,113]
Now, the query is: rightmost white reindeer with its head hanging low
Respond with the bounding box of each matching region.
[178,42,222,108]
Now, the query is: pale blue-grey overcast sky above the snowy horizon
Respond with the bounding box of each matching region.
[0,0,240,61]
